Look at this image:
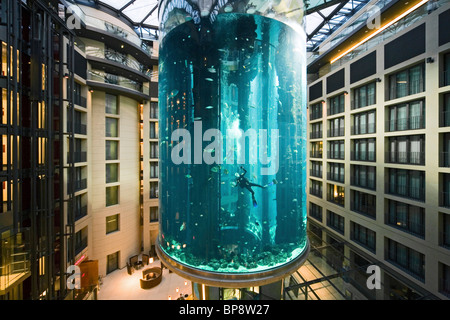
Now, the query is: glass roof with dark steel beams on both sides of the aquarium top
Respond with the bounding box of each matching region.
[71,0,369,51]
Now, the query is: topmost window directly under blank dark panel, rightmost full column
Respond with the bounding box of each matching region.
[389,63,425,100]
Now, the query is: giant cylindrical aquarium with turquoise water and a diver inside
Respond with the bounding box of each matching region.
[157,0,309,288]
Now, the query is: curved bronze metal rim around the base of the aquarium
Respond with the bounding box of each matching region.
[155,239,310,289]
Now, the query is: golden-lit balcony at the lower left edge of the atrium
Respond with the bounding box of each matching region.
[0,229,30,295]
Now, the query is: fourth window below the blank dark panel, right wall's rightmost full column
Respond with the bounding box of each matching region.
[386,168,425,201]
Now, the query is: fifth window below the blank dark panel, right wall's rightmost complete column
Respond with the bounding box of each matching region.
[385,199,425,238]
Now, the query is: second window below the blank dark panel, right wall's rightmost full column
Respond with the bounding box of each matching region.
[386,100,425,132]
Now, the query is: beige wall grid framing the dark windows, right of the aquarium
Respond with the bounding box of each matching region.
[308,4,450,299]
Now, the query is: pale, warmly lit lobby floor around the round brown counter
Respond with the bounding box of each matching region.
[98,260,192,300]
